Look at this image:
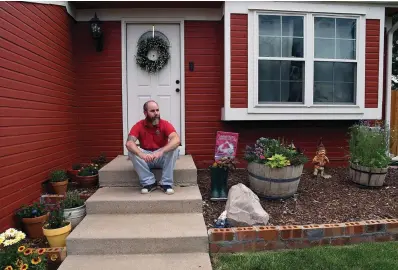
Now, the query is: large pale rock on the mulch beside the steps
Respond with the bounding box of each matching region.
[225,183,269,227]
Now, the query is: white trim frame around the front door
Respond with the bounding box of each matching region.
[121,17,186,155]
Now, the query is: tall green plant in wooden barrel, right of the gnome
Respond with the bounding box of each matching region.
[349,122,391,186]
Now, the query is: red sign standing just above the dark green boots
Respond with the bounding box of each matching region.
[214,131,239,160]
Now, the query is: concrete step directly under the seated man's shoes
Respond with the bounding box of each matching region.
[86,186,202,214]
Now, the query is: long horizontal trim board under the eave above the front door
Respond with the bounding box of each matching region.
[75,8,223,22]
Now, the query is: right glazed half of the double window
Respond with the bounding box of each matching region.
[314,17,357,104]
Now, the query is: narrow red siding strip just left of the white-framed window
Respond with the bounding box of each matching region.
[231,14,248,108]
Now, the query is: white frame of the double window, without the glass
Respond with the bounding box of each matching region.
[247,10,366,114]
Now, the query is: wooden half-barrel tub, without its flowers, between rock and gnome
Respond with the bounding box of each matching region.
[247,162,304,199]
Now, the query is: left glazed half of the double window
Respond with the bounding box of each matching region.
[258,15,305,103]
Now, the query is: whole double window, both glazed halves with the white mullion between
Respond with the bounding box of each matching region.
[253,13,358,107]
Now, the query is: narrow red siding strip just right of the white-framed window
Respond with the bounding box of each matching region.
[365,19,380,108]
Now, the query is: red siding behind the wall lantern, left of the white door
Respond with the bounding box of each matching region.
[74,22,123,162]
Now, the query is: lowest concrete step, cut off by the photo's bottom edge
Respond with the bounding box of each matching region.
[58,253,212,270]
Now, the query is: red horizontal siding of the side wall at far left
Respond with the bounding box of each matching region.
[0,2,79,231]
